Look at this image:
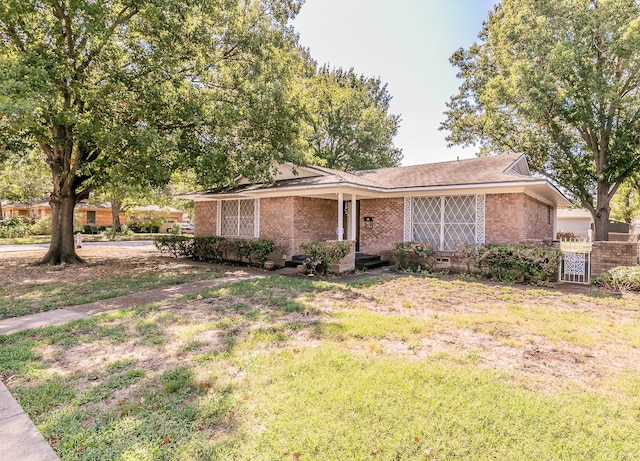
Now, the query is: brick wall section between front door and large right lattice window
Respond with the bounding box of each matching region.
[360,197,404,254]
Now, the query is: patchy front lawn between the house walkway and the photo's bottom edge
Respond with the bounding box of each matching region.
[0,276,640,460]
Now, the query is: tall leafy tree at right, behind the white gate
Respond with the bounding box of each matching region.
[442,0,640,240]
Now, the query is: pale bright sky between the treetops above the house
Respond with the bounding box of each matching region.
[293,0,496,165]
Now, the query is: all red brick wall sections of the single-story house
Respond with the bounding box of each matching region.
[195,193,554,261]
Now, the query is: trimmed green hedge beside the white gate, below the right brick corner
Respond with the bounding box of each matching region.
[472,243,562,283]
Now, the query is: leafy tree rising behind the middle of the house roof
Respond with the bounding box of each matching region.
[306,66,402,171]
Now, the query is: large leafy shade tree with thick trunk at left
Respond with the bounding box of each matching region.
[0,0,300,264]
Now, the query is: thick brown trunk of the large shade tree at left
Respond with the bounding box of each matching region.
[36,190,84,266]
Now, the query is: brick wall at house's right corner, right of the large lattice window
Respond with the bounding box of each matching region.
[485,193,554,243]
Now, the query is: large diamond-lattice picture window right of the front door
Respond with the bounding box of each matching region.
[411,195,484,251]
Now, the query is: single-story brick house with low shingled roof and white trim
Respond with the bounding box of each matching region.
[181,155,570,260]
